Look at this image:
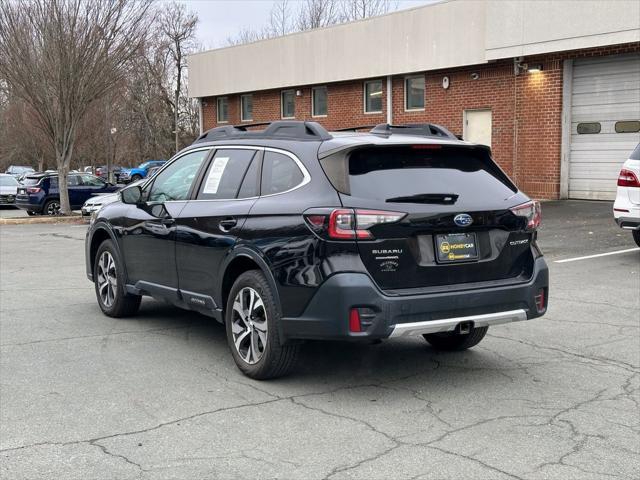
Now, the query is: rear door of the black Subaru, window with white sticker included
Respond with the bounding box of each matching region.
[176,147,263,312]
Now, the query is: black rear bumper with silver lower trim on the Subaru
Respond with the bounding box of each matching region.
[281,257,549,340]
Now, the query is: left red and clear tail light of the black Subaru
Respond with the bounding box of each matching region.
[305,208,407,240]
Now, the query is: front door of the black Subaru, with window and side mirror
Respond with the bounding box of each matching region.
[121,147,211,300]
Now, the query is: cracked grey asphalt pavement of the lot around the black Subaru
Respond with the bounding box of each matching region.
[0,201,640,480]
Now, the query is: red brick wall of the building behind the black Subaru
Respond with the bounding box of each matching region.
[203,43,640,199]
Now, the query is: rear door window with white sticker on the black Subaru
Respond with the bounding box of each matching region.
[198,149,257,200]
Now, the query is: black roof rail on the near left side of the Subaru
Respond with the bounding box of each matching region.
[193,120,333,143]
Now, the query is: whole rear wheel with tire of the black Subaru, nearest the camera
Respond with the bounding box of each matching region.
[225,270,299,380]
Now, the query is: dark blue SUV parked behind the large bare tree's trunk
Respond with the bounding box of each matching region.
[16,173,119,215]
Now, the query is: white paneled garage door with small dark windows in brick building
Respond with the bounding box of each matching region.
[569,54,640,200]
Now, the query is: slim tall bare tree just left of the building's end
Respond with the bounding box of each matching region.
[160,2,198,152]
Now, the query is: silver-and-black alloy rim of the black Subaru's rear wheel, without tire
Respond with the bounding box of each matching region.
[231,287,267,365]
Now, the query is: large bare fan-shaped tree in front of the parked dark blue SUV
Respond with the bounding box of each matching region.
[0,0,150,214]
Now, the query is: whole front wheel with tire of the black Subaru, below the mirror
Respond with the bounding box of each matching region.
[93,240,142,318]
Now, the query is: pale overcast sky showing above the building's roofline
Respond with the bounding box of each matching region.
[175,0,435,50]
